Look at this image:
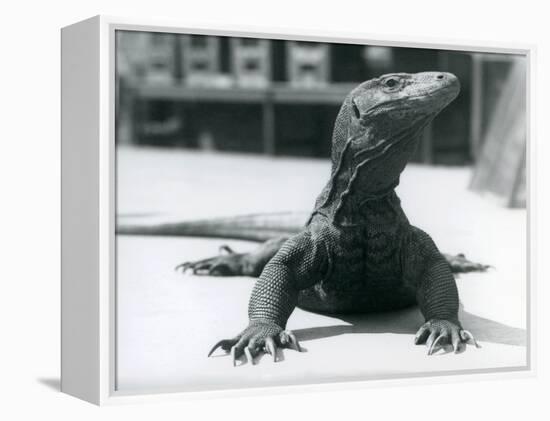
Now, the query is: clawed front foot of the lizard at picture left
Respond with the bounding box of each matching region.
[208,320,302,366]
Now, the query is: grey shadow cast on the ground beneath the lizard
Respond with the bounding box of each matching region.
[293,304,527,346]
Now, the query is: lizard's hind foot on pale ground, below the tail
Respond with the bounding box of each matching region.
[174,245,253,276]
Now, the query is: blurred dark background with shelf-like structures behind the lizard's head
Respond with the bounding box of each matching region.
[116,31,526,207]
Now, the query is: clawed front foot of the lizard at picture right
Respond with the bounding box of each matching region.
[414,319,480,355]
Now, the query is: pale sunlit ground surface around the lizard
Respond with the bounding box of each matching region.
[117,145,526,392]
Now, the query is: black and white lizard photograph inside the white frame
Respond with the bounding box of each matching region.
[114,30,529,394]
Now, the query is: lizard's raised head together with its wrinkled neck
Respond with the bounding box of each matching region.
[316,72,460,222]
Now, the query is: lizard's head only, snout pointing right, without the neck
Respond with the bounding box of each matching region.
[347,72,460,151]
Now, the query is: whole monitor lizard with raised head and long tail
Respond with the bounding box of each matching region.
[118,72,487,365]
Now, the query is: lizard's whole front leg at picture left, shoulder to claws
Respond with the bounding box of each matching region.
[208,231,326,365]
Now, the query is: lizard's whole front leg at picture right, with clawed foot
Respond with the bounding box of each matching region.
[407,228,478,355]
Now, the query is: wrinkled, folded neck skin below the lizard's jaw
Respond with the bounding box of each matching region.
[313,99,433,226]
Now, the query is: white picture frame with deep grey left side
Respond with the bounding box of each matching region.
[61,16,536,405]
